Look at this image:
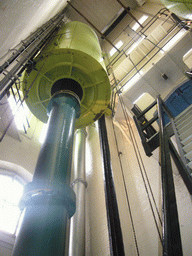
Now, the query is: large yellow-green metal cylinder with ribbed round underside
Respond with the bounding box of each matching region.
[23,21,111,128]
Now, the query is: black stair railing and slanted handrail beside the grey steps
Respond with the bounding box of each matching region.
[133,96,192,194]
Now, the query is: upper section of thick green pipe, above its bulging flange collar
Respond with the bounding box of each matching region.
[33,93,80,186]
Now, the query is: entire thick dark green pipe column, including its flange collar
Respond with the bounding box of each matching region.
[12,90,80,256]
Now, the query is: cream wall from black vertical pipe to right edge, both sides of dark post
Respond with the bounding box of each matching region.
[106,117,192,256]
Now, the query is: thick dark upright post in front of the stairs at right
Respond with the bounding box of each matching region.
[157,97,183,256]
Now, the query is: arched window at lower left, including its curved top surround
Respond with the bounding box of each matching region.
[0,161,32,238]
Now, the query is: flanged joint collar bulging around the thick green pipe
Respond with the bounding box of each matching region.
[20,182,76,218]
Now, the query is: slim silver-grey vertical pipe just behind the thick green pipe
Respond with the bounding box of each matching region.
[69,128,87,256]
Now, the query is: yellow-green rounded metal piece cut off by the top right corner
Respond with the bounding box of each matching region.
[161,0,192,20]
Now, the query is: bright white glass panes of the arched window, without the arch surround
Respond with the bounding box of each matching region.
[0,174,23,234]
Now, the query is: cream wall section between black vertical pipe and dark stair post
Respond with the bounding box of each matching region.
[106,118,160,256]
